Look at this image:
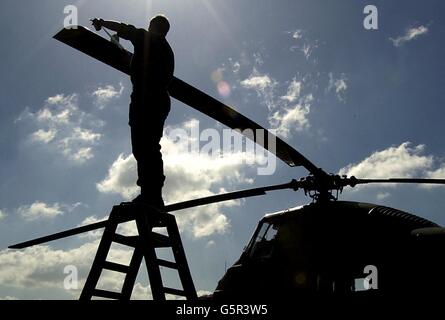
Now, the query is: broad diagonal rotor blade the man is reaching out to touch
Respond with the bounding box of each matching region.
[54,26,327,176]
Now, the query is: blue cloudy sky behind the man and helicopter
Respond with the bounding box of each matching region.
[0,0,445,299]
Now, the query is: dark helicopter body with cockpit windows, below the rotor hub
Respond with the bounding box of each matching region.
[214,201,445,299]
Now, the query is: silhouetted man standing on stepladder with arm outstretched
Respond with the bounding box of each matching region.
[92,15,174,207]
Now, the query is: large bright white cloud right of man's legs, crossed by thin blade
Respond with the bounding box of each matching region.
[162,127,252,237]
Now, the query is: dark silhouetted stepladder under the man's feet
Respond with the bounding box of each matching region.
[80,202,197,300]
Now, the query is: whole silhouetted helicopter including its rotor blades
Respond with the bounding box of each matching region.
[9,26,445,301]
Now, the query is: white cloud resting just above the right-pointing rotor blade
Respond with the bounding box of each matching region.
[339,142,433,178]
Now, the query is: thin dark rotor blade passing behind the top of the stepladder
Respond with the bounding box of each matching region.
[8,180,299,249]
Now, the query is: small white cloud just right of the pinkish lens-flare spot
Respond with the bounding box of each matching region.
[240,68,278,110]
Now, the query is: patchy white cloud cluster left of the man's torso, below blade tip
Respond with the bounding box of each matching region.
[17,94,103,164]
